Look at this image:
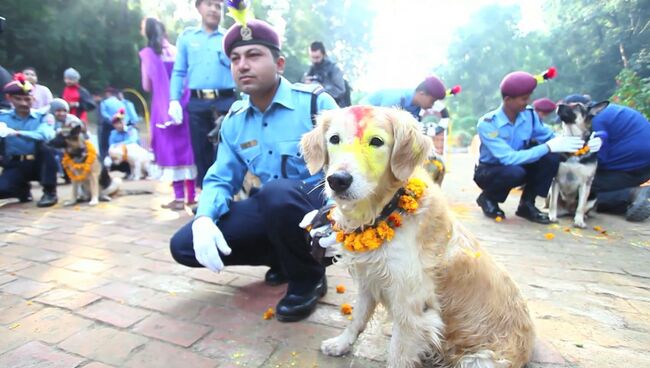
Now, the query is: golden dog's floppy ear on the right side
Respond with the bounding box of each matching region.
[387,109,433,181]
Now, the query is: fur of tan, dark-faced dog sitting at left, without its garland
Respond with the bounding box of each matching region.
[53,126,102,206]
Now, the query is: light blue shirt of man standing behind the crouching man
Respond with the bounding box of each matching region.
[169,27,235,101]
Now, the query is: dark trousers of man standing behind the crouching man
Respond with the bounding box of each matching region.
[187,97,235,188]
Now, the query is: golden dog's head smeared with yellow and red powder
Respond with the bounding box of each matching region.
[301,106,431,203]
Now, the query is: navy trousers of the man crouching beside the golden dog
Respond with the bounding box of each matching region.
[170,179,325,293]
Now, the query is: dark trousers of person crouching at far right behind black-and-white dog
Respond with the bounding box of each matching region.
[591,166,650,214]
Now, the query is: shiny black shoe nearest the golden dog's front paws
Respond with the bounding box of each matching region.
[275,275,327,322]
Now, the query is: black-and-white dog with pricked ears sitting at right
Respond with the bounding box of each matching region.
[548,101,609,228]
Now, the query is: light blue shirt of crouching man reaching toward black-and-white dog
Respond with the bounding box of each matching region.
[476,105,554,165]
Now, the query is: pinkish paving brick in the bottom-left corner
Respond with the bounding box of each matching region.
[0,341,84,368]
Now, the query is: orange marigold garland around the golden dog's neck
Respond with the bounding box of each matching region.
[328,178,427,252]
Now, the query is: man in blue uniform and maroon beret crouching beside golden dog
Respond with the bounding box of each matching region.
[171,15,337,321]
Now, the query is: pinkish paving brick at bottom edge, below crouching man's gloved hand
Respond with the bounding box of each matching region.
[124,341,217,368]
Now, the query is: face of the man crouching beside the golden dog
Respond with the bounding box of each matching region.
[230,45,284,97]
